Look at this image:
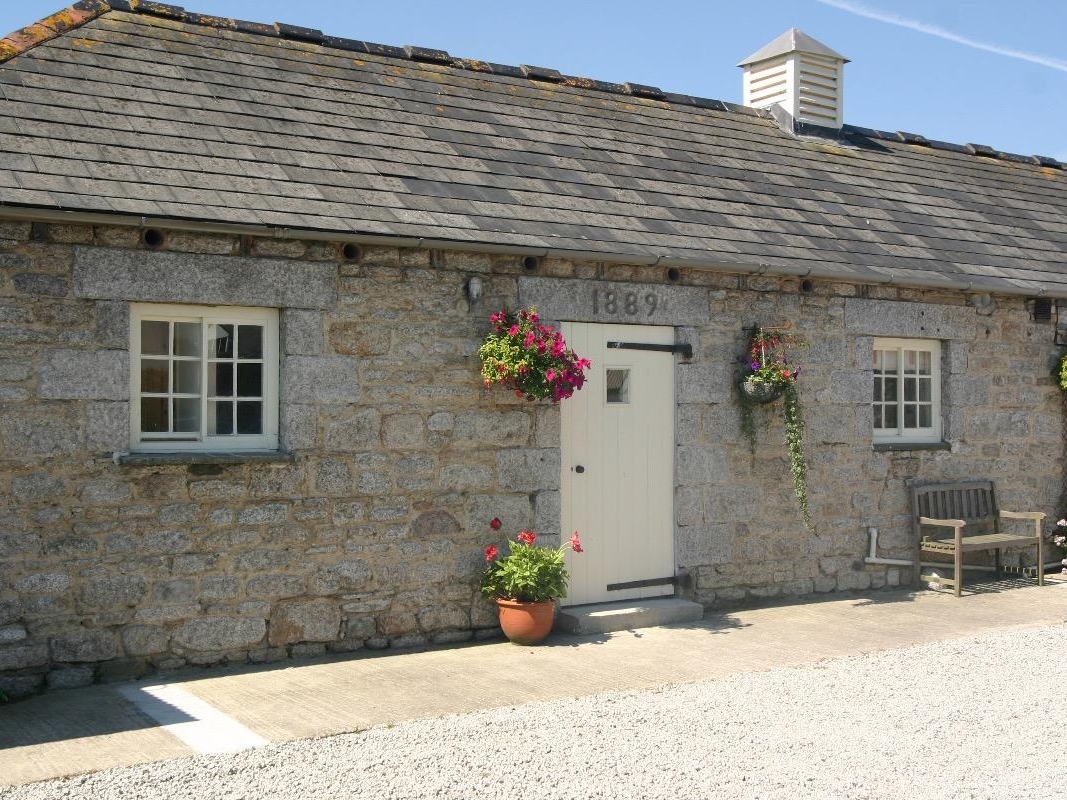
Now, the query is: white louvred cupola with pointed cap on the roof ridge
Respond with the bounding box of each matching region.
[737,28,848,128]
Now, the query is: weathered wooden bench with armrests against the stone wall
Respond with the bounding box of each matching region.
[911,481,1045,597]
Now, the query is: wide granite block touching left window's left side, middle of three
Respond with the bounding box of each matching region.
[37,350,129,400]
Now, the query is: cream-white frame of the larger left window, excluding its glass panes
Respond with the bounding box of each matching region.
[130,303,278,452]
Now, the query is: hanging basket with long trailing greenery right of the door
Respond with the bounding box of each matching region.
[737,324,813,530]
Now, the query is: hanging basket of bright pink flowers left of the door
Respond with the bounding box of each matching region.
[478,307,590,403]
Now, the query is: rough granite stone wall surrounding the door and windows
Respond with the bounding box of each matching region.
[0,222,1063,697]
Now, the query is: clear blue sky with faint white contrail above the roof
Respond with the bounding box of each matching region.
[6,0,1067,161]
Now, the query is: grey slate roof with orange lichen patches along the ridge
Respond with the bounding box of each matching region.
[0,0,1067,297]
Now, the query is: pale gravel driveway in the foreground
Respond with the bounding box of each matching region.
[0,624,1067,800]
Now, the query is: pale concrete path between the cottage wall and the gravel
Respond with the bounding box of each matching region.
[0,576,1067,786]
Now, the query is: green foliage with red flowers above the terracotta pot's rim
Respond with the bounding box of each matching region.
[481,530,582,603]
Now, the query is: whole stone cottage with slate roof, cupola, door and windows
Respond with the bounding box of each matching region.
[0,0,1067,695]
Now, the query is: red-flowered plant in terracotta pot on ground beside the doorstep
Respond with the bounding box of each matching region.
[481,518,582,644]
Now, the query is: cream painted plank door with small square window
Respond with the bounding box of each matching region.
[560,322,674,606]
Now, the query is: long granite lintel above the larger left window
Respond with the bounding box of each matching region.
[74,246,336,308]
